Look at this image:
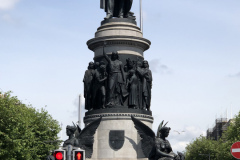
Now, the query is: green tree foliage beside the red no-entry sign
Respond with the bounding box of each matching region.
[186,112,240,160]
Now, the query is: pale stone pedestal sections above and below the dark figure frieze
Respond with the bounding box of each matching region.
[84,18,153,160]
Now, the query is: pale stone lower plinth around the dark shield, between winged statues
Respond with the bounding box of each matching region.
[84,108,153,160]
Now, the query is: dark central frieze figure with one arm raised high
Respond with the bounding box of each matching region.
[103,48,125,105]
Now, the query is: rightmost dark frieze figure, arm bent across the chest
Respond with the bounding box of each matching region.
[137,60,152,111]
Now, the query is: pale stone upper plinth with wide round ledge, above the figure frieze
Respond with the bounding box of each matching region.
[87,18,151,60]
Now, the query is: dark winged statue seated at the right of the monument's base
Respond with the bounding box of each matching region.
[132,116,185,160]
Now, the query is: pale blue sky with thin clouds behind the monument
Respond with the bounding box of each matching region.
[0,0,240,151]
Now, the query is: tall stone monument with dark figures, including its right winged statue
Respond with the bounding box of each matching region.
[80,0,184,160]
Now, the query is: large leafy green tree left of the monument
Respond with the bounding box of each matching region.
[0,92,60,160]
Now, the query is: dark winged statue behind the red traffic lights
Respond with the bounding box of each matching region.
[63,117,102,158]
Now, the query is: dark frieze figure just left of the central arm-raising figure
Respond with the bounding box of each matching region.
[93,65,108,108]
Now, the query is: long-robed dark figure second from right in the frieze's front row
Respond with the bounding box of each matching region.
[128,70,138,109]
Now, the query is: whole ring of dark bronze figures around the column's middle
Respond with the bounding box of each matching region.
[83,47,152,111]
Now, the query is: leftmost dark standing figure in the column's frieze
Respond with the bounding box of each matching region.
[83,62,94,110]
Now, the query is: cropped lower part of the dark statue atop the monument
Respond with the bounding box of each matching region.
[100,0,133,19]
